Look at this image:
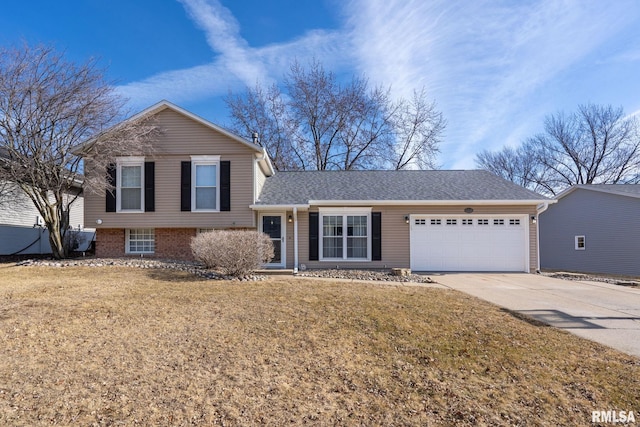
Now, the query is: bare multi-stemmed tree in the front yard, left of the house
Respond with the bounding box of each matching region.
[0,45,155,258]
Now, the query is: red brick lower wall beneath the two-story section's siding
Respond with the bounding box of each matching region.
[96,228,196,260]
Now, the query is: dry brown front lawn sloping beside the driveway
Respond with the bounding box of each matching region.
[0,265,640,425]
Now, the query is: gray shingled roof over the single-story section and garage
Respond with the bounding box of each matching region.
[256,170,549,205]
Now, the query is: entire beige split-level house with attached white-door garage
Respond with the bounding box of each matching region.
[85,101,552,272]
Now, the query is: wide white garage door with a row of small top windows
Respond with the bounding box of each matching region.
[410,215,529,271]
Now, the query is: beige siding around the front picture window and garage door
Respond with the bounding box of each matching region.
[298,205,538,272]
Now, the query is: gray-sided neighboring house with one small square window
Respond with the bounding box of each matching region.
[540,184,640,276]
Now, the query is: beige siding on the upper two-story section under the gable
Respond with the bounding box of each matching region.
[85,110,255,228]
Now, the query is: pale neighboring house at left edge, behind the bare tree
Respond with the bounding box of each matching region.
[0,179,93,255]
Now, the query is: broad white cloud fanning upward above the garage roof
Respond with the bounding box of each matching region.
[347,0,633,167]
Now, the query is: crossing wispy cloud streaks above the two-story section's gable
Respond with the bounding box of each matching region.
[118,0,348,112]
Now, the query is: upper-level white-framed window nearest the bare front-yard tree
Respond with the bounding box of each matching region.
[116,157,144,212]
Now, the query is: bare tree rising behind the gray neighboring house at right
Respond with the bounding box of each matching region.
[476,104,640,195]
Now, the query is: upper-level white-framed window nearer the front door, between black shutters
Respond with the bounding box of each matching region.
[191,156,220,212]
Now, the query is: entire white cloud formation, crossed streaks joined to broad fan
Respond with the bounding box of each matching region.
[119,0,640,168]
